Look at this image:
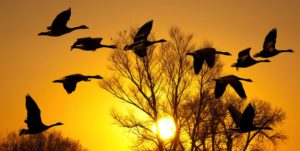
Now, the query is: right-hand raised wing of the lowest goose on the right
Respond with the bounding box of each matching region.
[240,103,255,127]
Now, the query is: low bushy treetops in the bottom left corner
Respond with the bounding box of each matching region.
[0,131,87,151]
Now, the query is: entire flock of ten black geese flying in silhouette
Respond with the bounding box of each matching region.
[19,8,293,135]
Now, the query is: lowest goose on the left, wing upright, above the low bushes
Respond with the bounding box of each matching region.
[19,94,63,136]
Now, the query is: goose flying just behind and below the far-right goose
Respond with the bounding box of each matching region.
[231,48,271,70]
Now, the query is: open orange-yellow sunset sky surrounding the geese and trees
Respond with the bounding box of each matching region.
[0,0,300,151]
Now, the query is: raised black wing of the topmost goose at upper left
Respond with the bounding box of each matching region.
[50,8,71,30]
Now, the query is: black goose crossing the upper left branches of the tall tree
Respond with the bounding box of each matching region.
[124,20,166,58]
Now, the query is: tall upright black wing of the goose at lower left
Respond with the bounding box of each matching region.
[25,95,43,129]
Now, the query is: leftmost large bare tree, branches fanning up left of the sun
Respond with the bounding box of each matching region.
[101,30,164,150]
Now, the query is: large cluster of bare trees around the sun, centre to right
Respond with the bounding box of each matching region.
[100,27,286,151]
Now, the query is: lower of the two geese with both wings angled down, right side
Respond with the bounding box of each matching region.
[213,75,253,99]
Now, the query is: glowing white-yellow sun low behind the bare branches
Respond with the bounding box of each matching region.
[152,117,176,140]
